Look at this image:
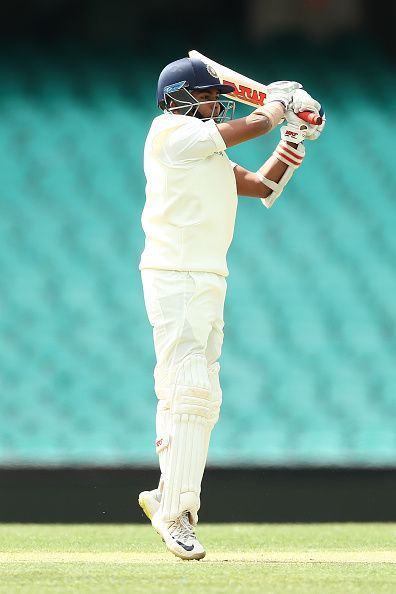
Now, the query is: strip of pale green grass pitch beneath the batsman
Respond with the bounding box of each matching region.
[0,524,396,594]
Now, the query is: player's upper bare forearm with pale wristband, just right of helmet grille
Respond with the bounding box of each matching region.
[217,101,285,147]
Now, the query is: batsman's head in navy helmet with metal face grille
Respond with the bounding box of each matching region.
[157,58,235,123]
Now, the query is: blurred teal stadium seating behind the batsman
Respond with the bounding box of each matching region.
[0,47,396,465]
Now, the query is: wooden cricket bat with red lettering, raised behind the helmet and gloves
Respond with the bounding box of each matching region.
[188,50,322,125]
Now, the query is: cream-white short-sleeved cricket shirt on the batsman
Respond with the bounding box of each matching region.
[140,113,238,276]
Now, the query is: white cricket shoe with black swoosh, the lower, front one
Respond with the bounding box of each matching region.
[151,511,206,560]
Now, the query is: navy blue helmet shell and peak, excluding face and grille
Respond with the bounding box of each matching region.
[157,58,234,109]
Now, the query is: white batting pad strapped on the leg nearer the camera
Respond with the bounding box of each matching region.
[159,355,221,524]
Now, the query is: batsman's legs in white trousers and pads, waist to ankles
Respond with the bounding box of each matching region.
[142,269,227,524]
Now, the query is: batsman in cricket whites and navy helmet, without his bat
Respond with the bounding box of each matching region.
[139,53,324,559]
